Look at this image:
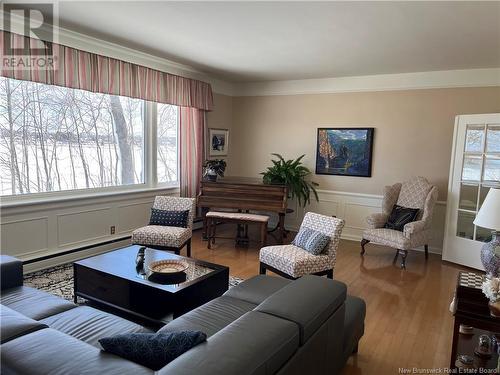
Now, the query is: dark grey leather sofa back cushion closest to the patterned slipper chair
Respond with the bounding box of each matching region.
[255,275,347,345]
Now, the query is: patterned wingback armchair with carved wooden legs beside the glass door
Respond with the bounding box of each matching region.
[361,177,438,268]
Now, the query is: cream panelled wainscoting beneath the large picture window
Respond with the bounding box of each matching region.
[0,188,178,269]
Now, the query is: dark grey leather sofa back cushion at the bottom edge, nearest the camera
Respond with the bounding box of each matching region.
[158,311,299,375]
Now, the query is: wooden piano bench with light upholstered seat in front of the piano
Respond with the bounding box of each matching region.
[206,211,269,249]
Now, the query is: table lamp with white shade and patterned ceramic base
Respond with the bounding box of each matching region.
[474,188,500,277]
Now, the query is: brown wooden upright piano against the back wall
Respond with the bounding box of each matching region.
[198,177,288,242]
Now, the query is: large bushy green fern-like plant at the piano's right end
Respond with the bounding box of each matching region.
[261,154,318,207]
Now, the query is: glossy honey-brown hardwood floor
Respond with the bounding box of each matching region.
[188,226,468,375]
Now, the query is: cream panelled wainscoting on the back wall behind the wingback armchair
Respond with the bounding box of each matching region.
[280,190,446,254]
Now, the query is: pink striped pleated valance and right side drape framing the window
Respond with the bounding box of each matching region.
[0,31,213,197]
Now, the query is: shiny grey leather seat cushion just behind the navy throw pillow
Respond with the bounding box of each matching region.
[41,306,148,349]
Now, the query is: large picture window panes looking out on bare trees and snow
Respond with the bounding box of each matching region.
[0,77,178,196]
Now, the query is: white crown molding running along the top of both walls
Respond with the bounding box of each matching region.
[0,11,500,96]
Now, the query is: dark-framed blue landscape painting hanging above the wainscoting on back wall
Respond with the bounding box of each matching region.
[316,128,373,177]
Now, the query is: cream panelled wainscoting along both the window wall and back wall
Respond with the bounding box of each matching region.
[0,189,446,272]
